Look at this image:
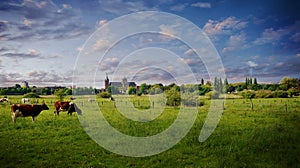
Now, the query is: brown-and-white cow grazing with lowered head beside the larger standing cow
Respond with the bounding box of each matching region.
[54,101,82,115]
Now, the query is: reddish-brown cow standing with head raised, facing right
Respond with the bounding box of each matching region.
[11,103,49,123]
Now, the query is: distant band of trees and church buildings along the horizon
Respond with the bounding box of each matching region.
[0,74,300,97]
